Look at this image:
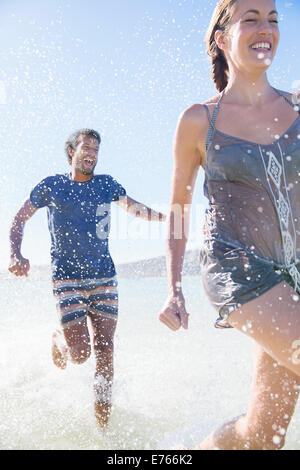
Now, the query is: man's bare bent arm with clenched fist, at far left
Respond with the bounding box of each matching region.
[8,199,37,276]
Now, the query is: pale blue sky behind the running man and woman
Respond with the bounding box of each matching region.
[0,0,300,269]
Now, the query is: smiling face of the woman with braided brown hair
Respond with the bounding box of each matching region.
[216,0,280,71]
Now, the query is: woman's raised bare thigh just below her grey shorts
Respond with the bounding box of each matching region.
[228,282,300,376]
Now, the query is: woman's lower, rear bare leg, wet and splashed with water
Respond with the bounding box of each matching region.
[198,343,300,450]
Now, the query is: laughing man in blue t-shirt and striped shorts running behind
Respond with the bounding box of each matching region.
[9,129,165,428]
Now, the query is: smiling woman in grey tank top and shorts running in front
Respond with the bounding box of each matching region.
[160,0,300,450]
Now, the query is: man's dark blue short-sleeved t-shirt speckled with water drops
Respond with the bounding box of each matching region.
[30,175,126,280]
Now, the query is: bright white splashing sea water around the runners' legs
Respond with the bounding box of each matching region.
[0,267,300,450]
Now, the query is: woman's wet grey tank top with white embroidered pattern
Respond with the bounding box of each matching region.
[200,90,300,289]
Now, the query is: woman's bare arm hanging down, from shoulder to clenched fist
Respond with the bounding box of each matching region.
[159,105,207,331]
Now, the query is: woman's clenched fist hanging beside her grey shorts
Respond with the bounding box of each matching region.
[159,293,189,331]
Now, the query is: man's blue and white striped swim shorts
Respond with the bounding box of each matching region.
[53,277,118,328]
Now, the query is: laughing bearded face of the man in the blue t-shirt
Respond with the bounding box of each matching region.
[69,135,99,175]
